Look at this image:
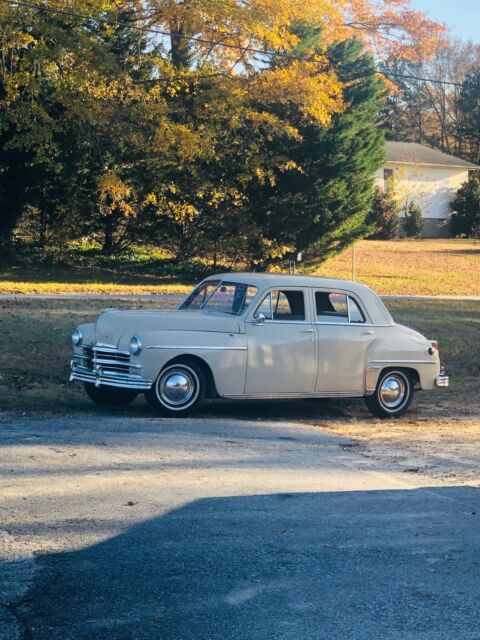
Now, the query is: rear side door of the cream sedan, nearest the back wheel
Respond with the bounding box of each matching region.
[312,289,375,395]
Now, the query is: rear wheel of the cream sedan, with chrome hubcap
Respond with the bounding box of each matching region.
[365,369,415,418]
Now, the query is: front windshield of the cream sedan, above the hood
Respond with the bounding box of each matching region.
[180,280,257,315]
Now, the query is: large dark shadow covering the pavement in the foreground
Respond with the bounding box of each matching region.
[8,487,480,640]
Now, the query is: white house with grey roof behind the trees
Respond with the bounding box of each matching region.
[376,141,480,238]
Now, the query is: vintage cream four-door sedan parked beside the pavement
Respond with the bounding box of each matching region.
[70,273,448,417]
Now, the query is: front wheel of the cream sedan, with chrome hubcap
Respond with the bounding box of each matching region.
[145,362,205,417]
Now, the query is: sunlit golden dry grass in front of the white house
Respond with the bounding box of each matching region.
[316,239,480,296]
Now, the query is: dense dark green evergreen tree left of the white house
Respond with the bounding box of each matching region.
[244,33,384,268]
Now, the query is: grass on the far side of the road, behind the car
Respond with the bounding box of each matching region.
[0,240,480,296]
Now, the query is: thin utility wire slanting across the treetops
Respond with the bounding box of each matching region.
[0,0,463,88]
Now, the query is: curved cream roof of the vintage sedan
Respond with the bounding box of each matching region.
[205,271,395,325]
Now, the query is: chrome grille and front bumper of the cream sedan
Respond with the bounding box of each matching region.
[70,345,152,391]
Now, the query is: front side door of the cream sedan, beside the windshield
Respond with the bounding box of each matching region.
[245,287,317,395]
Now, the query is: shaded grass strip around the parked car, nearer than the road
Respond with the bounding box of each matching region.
[0,299,480,416]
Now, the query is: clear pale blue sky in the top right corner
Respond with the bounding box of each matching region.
[411,0,480,44]
